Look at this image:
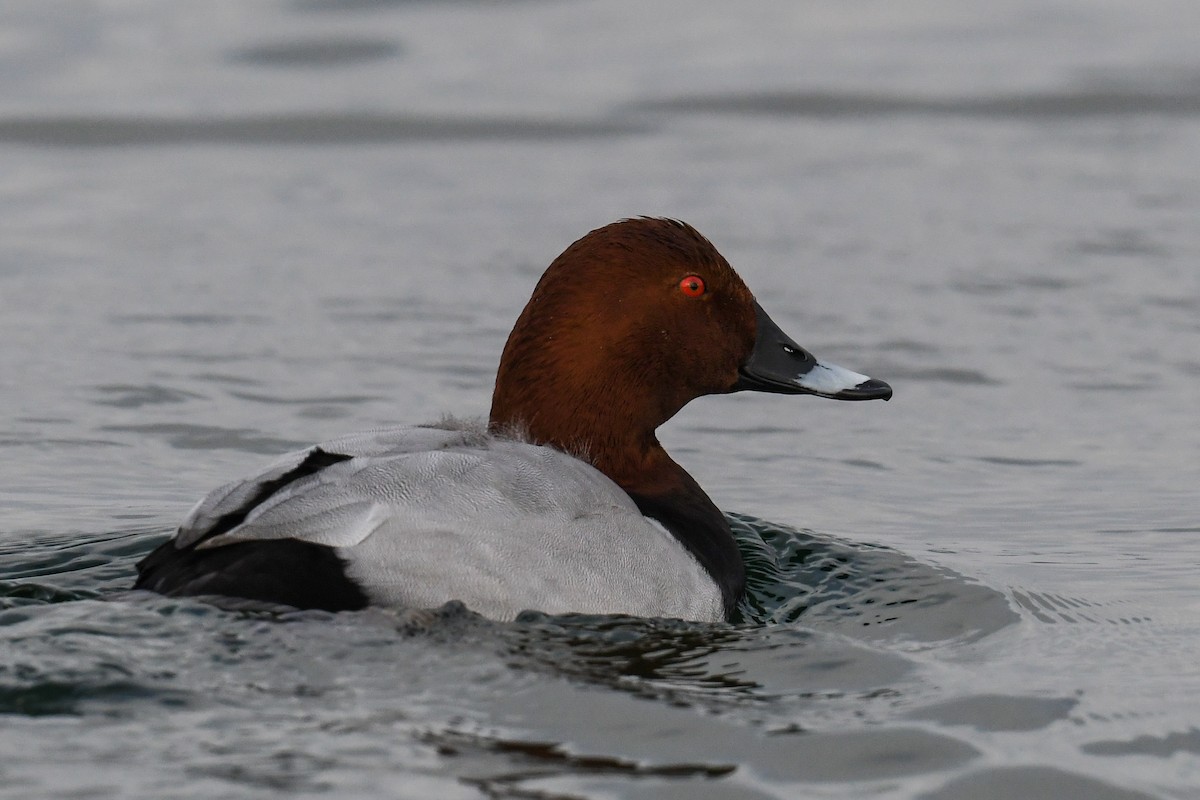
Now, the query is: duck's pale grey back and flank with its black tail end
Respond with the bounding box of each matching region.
[139,422,726,620]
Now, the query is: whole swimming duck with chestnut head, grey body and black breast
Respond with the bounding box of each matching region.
[133,217,892,622]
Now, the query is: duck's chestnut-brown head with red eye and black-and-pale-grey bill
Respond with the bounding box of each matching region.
[491,217,892,451]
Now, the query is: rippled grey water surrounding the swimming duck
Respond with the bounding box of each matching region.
[0,0,1200,800]
